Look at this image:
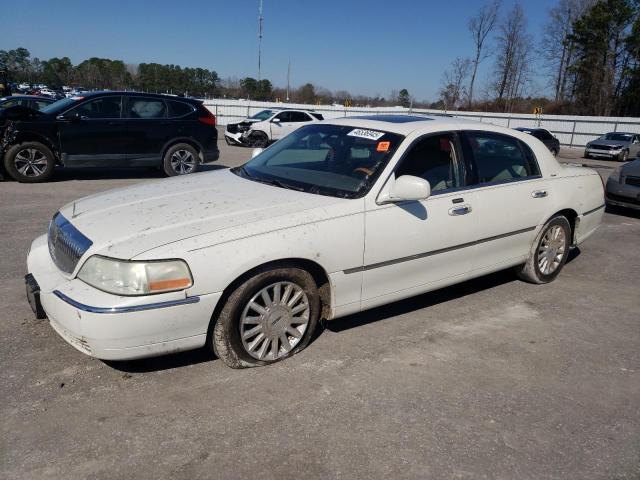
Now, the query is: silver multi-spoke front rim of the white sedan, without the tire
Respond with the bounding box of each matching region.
[240,282,310,360]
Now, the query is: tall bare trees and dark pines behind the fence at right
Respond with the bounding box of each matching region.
[434,0,640,116]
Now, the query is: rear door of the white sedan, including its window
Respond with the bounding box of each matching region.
[462,131,553,270]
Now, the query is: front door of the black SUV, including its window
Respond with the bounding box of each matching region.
[57,95,127,167]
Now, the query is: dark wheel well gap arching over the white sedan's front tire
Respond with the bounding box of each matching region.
[207,258,331,341]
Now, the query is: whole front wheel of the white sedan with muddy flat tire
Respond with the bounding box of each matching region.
[209,268,320,368]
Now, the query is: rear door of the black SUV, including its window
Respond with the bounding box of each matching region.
[124,95,172,166]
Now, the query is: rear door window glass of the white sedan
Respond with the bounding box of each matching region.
[466,132,540,183]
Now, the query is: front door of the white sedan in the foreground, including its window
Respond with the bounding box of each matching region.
[362,133,478,308]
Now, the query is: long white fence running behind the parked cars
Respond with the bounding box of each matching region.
[204,99,640,147]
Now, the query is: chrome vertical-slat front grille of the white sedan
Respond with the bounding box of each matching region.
[48,212,93,273]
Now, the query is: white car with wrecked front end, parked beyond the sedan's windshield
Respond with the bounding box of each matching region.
[224,108,323,148]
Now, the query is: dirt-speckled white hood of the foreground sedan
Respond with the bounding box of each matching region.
[60,169,349,259]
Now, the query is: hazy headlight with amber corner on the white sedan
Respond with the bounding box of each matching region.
[78,255,193,295]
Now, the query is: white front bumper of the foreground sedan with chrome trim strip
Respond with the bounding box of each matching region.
[27,235,221,360]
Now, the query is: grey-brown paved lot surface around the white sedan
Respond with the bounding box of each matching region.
[0,136,640,479]
